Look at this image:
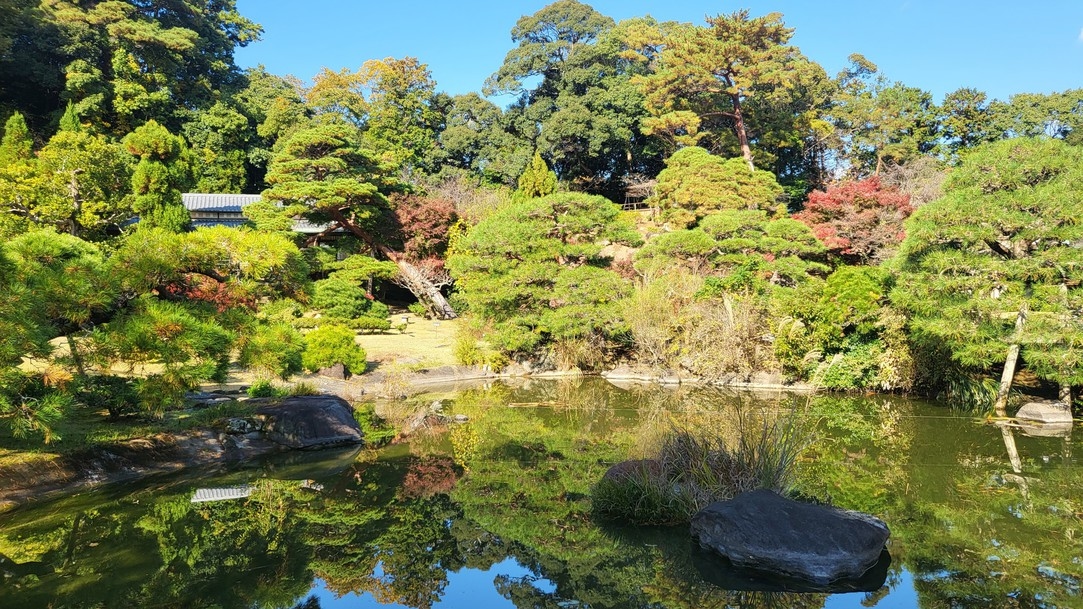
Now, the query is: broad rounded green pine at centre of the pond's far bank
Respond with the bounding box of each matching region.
[447,193,639,353]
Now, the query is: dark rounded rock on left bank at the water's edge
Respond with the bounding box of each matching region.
[256,396,363,449]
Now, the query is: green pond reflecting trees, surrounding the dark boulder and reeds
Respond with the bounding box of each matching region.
[0,379,1083,609]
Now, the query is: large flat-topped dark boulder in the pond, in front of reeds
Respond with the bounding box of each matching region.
[692,490,890,584]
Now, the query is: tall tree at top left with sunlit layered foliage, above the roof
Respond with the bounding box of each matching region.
[47,0,262,135]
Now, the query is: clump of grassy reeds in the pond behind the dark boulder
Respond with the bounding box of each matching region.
[591,415,809,524]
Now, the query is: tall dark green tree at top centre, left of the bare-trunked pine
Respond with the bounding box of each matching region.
[483,0,658,195]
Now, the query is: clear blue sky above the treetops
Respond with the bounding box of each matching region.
[236,0,1083,102]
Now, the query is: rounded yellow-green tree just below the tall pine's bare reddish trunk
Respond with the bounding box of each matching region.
[650,146,785,228]
